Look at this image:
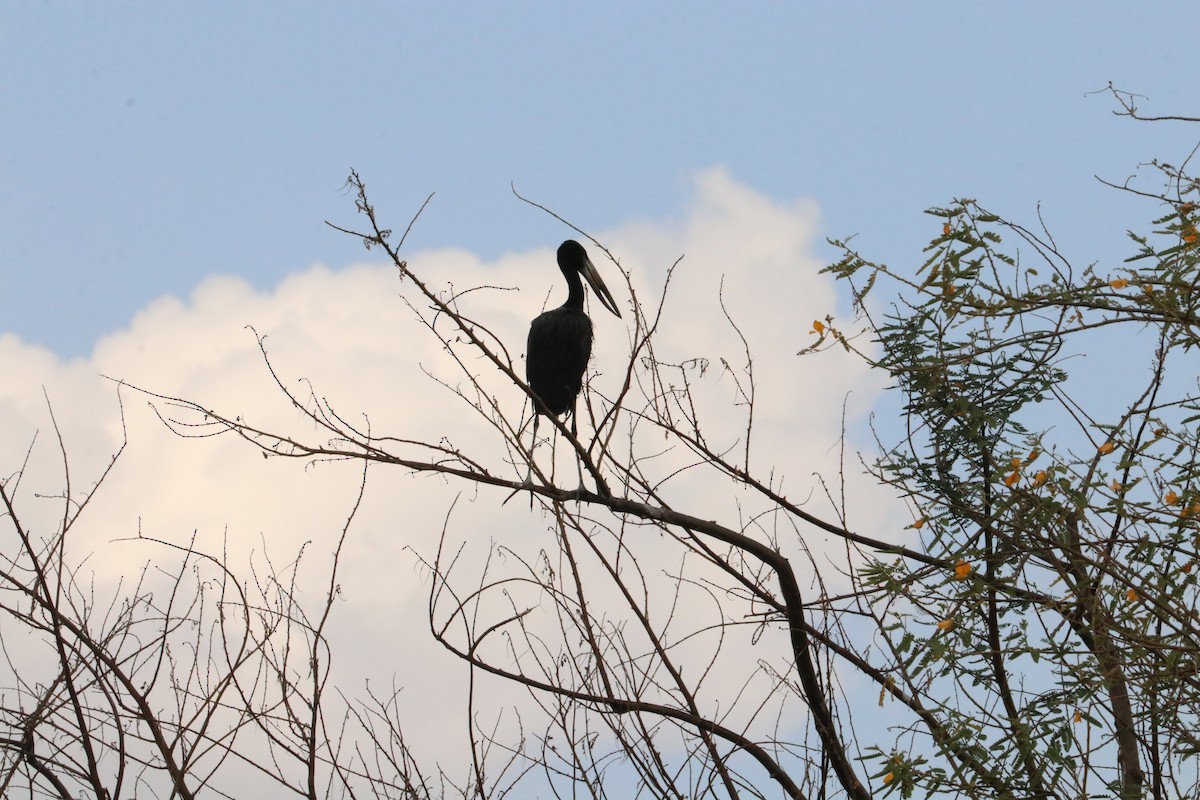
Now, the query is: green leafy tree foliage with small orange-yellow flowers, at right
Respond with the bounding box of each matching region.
[828,142,1200,796]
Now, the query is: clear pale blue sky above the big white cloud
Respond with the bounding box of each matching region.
[0,2,1200,356]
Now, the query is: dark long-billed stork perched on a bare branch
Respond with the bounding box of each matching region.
[526,239,620,483]
